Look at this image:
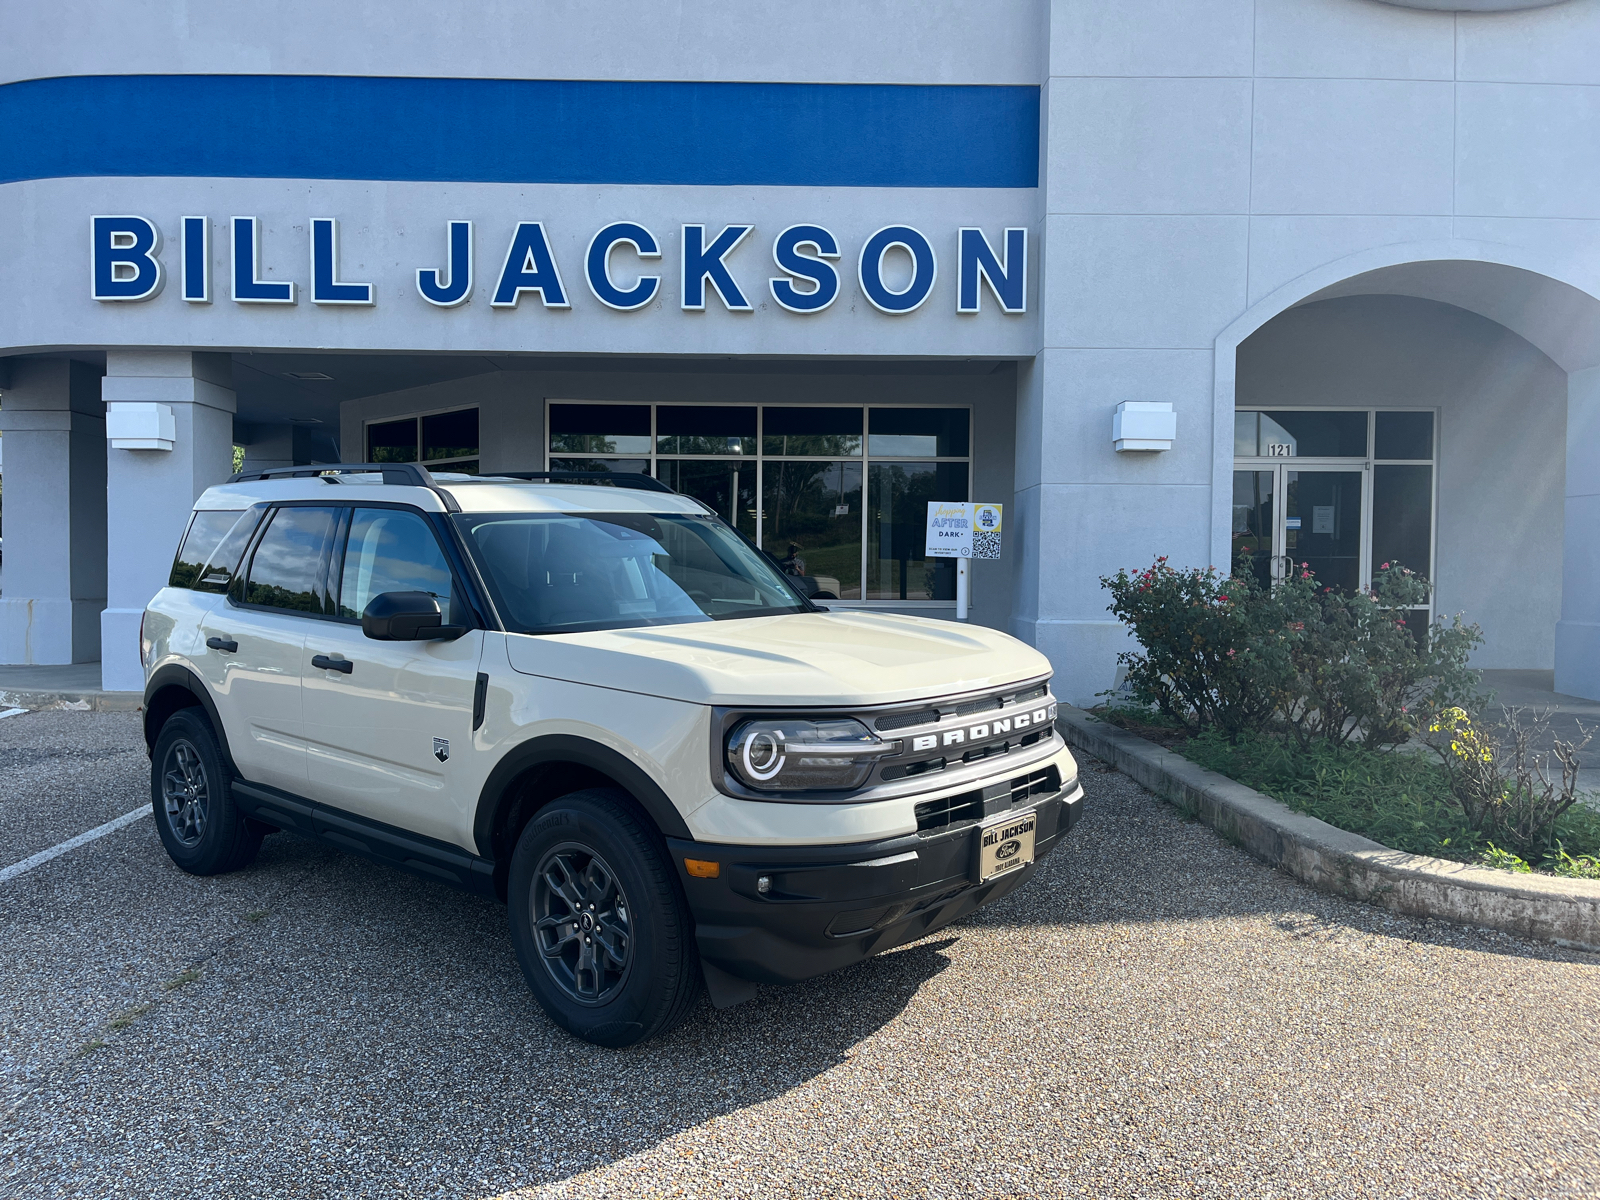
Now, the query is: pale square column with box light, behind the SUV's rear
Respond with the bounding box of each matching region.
[101,350,237,691]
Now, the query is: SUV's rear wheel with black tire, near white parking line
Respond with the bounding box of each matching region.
[150,709,261,875]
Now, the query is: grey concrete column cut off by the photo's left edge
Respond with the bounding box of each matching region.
[0,358,106,664]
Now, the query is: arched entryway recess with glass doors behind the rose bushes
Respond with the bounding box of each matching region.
[1213,243,1600,698]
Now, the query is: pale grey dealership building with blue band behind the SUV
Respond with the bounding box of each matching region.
[0,0,1600,702]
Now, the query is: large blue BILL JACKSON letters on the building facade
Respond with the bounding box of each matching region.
[90,216,1027,315]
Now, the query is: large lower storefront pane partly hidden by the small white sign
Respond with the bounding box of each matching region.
[866,462,966,600]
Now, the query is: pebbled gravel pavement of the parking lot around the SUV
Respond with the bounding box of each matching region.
[0,714,1600,1198]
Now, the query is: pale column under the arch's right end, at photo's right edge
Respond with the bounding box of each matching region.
[1555,366,1600,699]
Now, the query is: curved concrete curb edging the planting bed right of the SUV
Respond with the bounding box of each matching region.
[1058,704,1600,950]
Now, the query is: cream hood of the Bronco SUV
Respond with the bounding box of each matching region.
[506,611,1050,706]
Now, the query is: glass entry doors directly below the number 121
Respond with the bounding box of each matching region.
[1234,464,1365,592]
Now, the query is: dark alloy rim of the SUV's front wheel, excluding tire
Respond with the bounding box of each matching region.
[531,842,634,1005]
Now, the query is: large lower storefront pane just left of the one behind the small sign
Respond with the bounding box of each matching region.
[762,460,862,600]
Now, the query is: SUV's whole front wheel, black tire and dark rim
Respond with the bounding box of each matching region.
[507,787,701,1046]
